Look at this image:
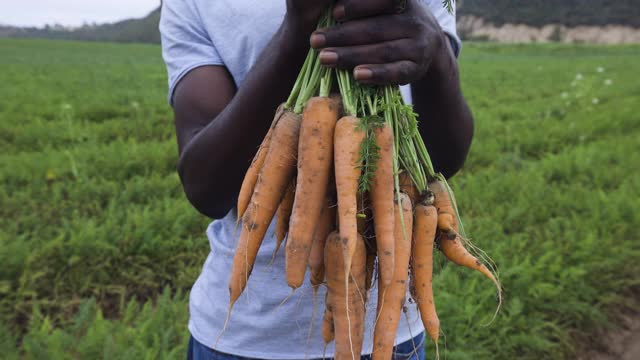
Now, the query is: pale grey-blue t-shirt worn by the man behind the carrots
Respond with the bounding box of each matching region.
[160,0,459,359]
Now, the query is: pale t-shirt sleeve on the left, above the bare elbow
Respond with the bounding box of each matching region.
[159,0,224,106]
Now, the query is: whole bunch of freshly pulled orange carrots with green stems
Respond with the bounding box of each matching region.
[229,6,501,360]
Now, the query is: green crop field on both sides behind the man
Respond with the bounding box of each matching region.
[0,40,640,359]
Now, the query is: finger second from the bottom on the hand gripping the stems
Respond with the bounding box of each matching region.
[320,39,417,68]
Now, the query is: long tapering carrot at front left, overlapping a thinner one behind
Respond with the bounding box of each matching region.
[229,112,300,312]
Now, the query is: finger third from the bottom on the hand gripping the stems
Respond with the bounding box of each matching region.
[311,15,419,49]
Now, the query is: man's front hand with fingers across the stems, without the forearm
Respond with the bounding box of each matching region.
[311,0,444,85]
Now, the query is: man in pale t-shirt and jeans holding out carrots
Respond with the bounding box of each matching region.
[160,0,473,359]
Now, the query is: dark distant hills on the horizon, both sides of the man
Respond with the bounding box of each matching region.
[0,0,640,43]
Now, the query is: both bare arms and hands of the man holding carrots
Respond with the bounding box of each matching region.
[174,0,473,219]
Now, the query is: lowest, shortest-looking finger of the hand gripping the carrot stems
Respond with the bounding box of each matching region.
[353,60,420,85]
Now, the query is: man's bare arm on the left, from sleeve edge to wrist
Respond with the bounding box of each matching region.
[173,5,326,218]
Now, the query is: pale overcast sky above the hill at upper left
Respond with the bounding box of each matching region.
[0,0,160,27]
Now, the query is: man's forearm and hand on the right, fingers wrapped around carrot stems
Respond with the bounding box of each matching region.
[310,0,473,177]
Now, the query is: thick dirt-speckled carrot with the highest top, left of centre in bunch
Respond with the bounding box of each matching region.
[286,97,339,289]
